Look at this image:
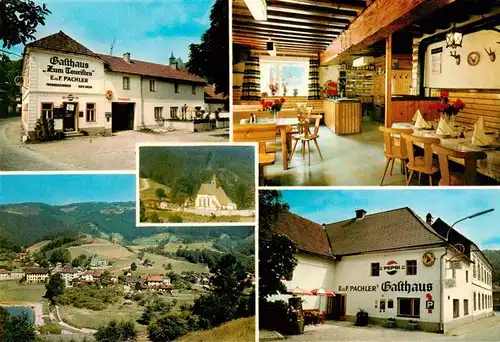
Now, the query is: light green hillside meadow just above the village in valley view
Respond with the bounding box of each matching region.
[69,242,207,275]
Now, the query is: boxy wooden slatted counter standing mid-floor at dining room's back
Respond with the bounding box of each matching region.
[323,98,362,135]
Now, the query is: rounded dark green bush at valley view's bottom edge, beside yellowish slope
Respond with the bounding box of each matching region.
[148,313,189,342]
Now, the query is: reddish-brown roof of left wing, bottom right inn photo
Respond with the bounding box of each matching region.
[275,212,332,257]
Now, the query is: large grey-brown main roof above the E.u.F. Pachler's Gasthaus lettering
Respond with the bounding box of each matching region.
[326,207,446,255]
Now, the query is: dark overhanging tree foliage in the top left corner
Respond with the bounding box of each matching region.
[0,0,51,49]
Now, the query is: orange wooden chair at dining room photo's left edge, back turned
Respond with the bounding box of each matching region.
[233,123,276,185]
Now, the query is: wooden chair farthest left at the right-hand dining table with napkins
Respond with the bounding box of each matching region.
[378,126,413,186]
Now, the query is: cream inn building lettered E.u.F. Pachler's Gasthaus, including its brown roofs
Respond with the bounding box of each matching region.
[270,208,493,332]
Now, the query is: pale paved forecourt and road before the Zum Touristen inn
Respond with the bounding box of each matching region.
[0,117,229,171]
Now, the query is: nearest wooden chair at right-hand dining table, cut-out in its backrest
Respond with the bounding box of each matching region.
[431,144,486,185]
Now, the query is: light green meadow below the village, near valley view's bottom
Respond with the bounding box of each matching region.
[59,303,146,331]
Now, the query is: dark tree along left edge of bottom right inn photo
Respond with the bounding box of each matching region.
[259,190,297,301]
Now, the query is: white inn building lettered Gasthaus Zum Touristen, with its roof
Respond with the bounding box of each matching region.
[21,31,206,138]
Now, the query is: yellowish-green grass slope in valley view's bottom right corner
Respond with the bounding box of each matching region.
[178,317,255,342]
